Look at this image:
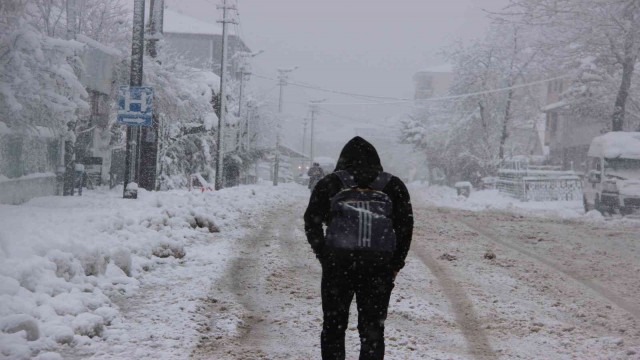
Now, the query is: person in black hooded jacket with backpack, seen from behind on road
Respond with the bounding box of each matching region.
[304,137,413,360]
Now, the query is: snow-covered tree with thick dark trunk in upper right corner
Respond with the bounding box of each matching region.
[499,0,640,131]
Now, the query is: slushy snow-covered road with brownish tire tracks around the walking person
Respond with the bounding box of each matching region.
[186,198,640,359]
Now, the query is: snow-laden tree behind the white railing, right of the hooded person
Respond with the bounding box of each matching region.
[403,24,541,183]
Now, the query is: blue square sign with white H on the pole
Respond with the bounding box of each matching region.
[118,86,153,126]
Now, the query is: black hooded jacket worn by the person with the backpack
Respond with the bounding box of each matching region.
[304,136,413,271]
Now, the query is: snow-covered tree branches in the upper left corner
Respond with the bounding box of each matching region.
[0,0,87,131]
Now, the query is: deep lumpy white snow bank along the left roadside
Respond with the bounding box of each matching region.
[0,184,295,359]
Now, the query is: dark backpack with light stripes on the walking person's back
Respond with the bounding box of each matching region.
[325,170,396,253]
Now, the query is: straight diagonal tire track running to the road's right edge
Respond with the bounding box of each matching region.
[457,215,640,320]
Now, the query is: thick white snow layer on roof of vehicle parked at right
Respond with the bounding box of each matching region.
[588,131,640,159]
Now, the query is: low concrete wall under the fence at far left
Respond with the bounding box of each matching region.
[0,174,56,205]
